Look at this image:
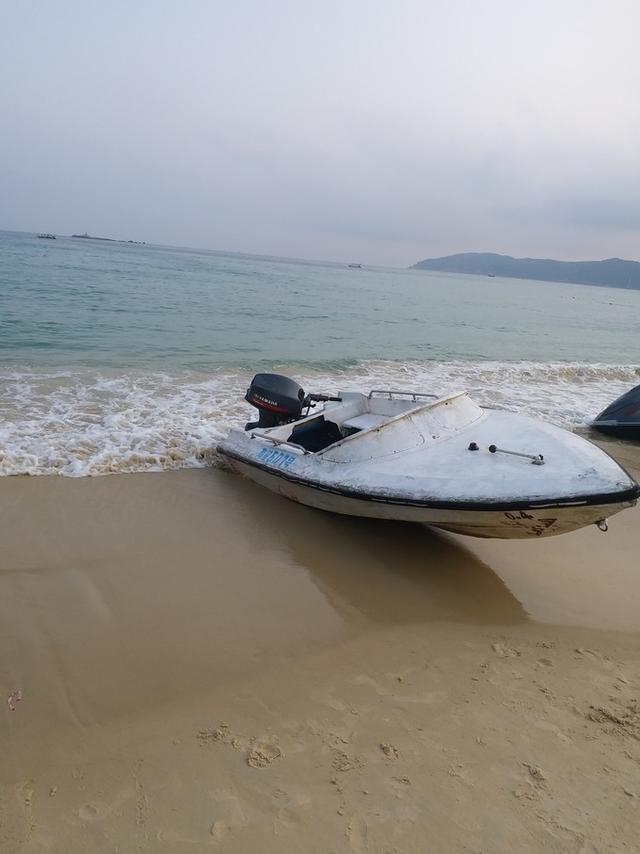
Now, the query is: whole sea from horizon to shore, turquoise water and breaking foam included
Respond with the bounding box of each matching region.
[0,232,640,475]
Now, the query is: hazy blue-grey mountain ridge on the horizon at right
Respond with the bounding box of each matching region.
[412,252,640,289]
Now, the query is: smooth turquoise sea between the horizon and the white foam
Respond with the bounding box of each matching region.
[5,232,640,370]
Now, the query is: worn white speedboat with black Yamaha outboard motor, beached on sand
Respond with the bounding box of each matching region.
[218,374,640,539]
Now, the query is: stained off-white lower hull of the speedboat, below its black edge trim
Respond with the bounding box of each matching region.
[227,459,635,540]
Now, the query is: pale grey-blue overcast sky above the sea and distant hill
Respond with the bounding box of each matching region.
[0,0,640,266]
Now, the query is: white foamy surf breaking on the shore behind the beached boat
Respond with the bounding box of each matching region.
[0,360,640,477]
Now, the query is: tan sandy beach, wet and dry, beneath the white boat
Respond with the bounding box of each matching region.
[0,443,640,854]
